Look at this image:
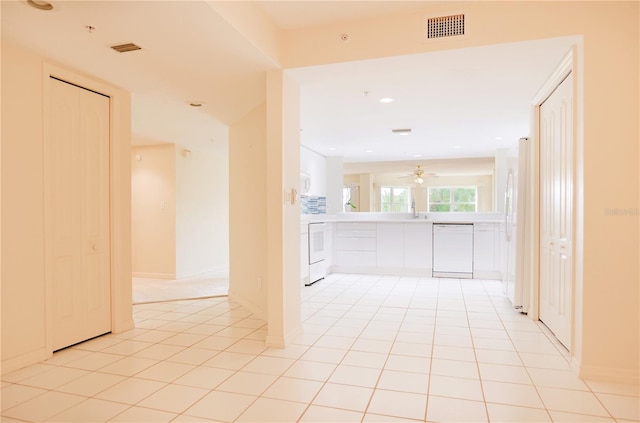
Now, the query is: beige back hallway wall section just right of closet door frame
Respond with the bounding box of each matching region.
[131,144,176,279]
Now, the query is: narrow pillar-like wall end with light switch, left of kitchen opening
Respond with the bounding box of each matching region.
[266,71,302,348]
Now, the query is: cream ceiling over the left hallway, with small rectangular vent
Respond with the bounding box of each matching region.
[1,0,275,148]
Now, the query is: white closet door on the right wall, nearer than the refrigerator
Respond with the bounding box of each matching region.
[540,74,573,348]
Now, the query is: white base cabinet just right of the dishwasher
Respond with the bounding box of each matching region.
[473,222,501,279]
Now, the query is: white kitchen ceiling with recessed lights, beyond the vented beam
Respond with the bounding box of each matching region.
[290,39,571,166]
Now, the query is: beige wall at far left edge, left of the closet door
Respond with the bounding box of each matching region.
[1,40,46,361]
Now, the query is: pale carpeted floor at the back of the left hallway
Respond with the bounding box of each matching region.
[133,274,229,304]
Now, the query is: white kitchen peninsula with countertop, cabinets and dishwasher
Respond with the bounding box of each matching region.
[312,212,504,279]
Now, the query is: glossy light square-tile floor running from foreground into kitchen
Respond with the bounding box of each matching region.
[1,274,640,422]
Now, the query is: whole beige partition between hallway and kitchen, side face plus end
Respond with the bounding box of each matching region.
[229,71,302,347]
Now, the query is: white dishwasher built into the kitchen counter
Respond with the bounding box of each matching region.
[433,223,473,279]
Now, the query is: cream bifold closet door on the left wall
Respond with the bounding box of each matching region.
[45,78,111,351]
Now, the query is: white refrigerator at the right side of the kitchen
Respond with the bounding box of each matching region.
[502,138,532,313]
